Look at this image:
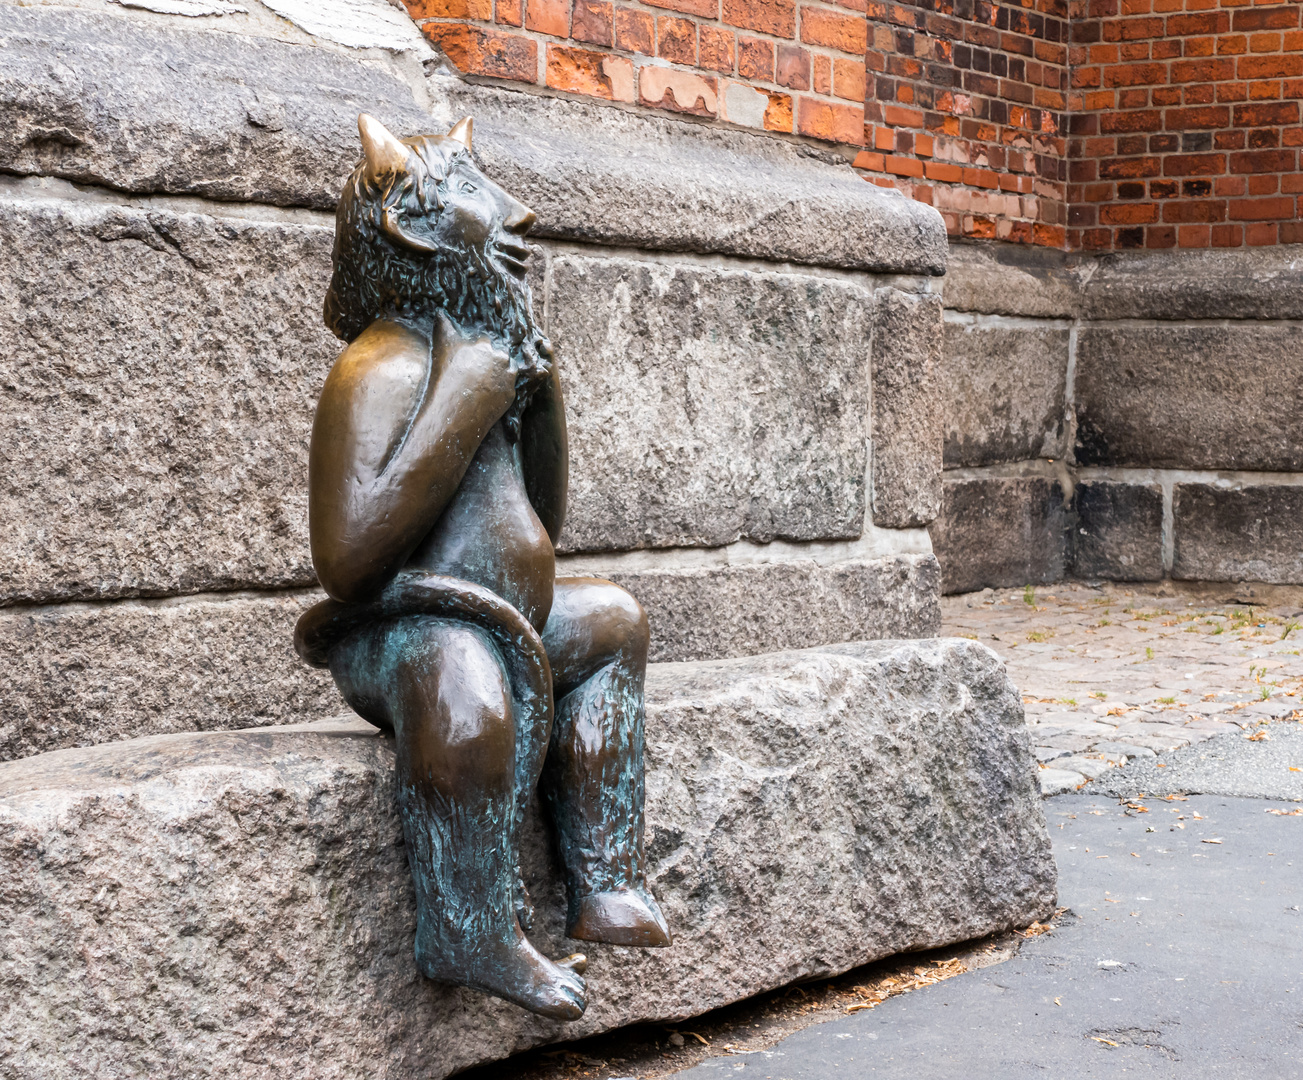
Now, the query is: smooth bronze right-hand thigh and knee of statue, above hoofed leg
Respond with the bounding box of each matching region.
[543,577,648,697]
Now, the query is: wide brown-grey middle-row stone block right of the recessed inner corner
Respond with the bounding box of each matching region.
[1075,321,1303,472]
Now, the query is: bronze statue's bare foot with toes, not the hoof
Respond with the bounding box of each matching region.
[416,934,588,1020]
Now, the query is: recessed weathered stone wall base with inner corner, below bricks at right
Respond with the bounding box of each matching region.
[932,239,1303,593]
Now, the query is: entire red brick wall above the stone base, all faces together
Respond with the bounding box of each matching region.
[404,0,1303,250]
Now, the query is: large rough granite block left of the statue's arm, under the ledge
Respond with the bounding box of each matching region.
[0,187,339,603]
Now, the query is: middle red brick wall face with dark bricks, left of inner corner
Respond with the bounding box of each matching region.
[855,0,1068,246]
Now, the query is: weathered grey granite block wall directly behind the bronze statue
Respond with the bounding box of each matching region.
[0,0,946,757]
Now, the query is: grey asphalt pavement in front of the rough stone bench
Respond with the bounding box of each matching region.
[678,723,1303,1080]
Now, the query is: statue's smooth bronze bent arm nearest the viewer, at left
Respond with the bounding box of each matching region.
[308,324,515,602]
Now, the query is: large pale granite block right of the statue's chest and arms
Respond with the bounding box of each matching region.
[550,255,873,551]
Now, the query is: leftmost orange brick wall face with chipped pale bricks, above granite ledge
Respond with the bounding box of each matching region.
[404,0,865,145]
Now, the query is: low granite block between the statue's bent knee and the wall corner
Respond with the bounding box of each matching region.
[607,555,941,661]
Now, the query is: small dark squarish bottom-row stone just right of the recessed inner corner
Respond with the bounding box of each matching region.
[1070,479,1162,581]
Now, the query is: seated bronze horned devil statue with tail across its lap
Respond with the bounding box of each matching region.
[294,115,670,1019]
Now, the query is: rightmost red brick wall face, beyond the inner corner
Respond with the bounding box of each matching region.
[1068,0,1303,250]
